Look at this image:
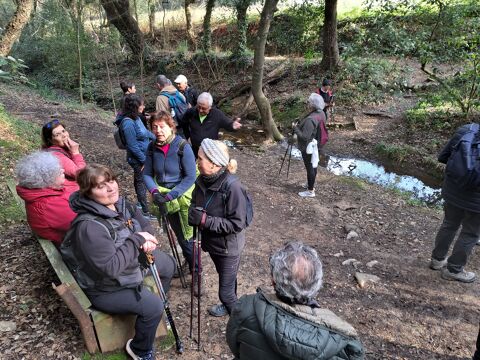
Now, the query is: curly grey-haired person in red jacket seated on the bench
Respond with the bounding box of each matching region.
[16,151,76,246]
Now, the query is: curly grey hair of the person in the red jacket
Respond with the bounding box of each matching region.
[15,151,62,189]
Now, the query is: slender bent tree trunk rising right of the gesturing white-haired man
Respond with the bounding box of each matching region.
[252,0,283,140]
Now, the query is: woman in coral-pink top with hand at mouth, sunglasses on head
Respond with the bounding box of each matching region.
[42,119,86,192]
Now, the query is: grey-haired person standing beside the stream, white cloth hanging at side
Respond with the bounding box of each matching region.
[292,93,328,197]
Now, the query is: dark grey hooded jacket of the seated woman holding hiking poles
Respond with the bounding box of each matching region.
[62,191,150,295]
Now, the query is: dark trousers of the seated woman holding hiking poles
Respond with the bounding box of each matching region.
[89,250,175,356]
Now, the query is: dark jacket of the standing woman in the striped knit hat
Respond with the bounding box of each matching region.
[190,171,247,256]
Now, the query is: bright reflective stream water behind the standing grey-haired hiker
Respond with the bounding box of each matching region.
[283,139,441,204]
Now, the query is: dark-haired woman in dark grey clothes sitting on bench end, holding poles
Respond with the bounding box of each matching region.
[61,164,175,359]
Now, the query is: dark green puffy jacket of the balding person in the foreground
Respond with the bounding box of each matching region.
[227,290,364,360]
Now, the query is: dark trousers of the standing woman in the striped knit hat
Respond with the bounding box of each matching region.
[210,254,240,314]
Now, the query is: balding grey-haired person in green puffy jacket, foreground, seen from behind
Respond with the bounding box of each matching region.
[226,242,365,360]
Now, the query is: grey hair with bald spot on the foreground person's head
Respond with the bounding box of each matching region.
[270,242,323,304]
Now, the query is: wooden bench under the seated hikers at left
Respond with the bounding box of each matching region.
[7,180,167,354]
